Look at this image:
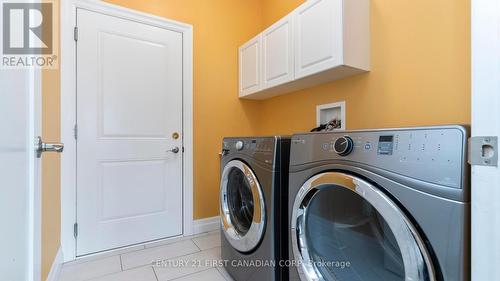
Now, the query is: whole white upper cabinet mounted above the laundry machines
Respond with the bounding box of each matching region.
[240,0,370,99]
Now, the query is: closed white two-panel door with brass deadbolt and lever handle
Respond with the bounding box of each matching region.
[77,9,183,256]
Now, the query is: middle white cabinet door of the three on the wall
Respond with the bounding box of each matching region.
[262,16,294,89]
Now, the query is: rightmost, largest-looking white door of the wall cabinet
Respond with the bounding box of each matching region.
[294,0,343,79]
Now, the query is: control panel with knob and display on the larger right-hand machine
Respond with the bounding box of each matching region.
[290,126,467,188]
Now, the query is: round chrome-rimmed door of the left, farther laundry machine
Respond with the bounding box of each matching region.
[220,160,266,252]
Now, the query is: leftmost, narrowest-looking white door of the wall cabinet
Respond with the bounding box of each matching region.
[239,34,261,97]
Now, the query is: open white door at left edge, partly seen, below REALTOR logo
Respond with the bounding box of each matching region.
[0,69,41,281]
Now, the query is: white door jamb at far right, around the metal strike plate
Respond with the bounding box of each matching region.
[471,0,500,281]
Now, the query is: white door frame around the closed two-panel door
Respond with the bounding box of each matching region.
[60,0,193,262]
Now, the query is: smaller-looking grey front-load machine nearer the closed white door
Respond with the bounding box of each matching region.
[220,136,290,281]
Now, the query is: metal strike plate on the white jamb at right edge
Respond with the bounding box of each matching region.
[467,136,498,167]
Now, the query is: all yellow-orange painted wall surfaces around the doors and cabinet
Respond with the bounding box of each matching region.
[42,0,470,279]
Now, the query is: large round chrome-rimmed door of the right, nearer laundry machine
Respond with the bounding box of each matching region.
[291,172,436,281]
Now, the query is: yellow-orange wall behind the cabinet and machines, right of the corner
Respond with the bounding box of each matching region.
[259,0,470,134]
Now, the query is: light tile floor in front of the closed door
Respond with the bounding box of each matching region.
[59,231,232,281]
